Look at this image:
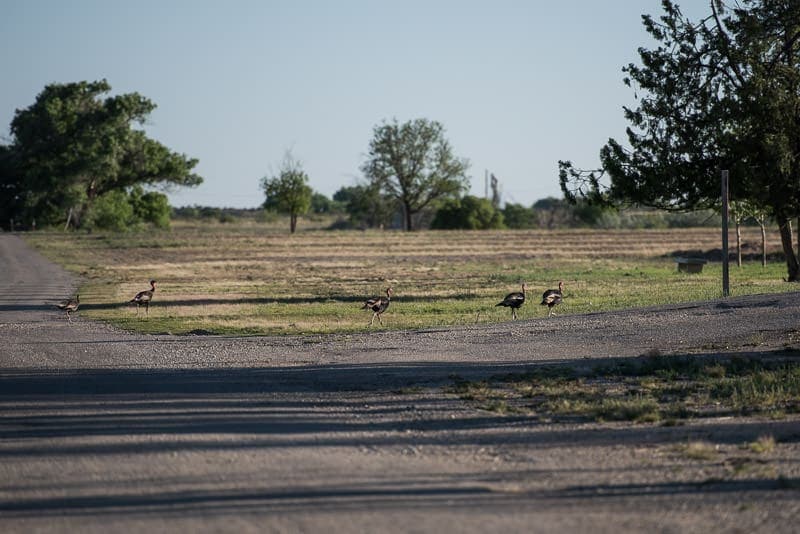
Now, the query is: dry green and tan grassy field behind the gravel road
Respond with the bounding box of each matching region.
[24,222,796,335]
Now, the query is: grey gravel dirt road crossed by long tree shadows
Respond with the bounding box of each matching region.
[0,234,800,533]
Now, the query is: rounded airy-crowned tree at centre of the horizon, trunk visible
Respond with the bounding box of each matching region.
[362,119,469,231]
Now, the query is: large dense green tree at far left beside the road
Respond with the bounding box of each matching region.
[0,80,202,226]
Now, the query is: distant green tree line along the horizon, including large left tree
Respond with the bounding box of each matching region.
[0,70,766,239]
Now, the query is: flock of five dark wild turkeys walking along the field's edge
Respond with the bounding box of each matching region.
[58,280,564,326]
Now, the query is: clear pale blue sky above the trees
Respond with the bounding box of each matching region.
[0,0,707,207]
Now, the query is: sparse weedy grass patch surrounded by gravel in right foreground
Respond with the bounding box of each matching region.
[449,355,800,426]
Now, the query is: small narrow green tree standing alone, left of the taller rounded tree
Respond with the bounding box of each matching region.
[261,151,313,233]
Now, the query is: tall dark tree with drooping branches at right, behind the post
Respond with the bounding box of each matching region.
[559,0,800,281]
